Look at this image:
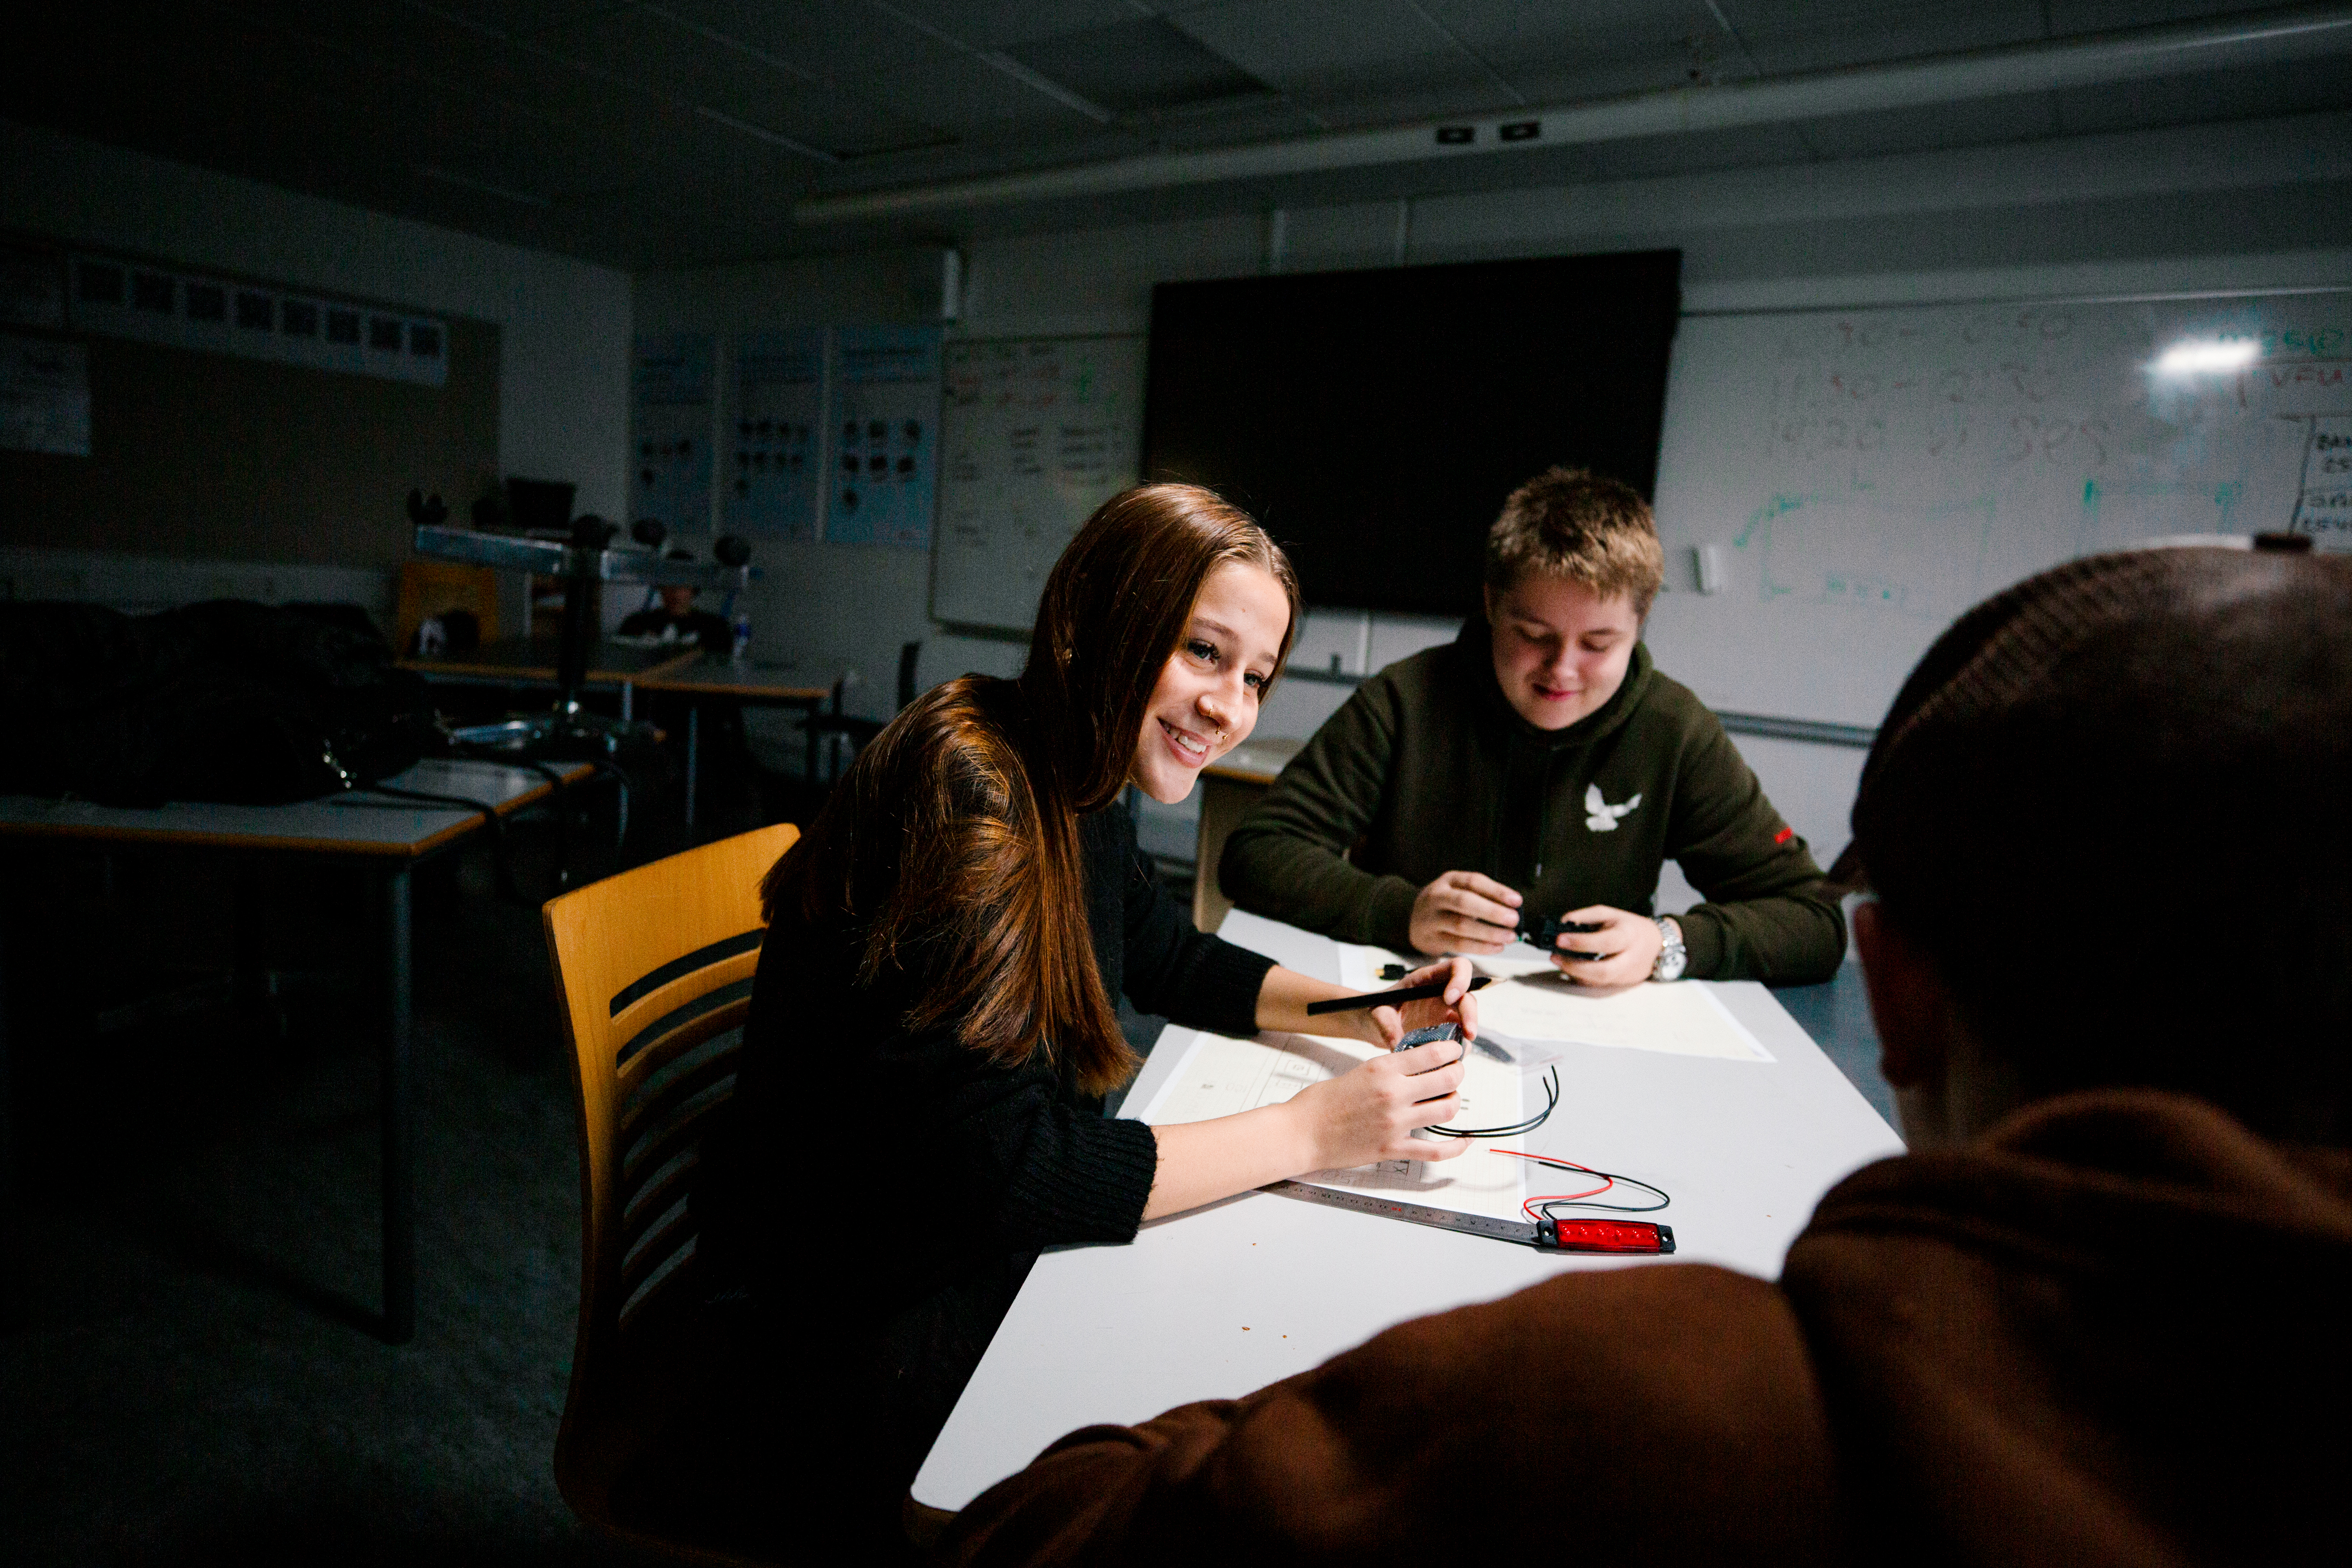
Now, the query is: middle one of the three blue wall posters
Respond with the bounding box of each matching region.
[720,329,826,538]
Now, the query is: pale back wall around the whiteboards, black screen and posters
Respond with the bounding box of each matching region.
[640,113,2352,870]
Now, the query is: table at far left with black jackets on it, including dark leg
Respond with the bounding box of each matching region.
[0,762,593,1345]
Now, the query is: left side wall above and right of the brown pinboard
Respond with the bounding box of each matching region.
[0,122,633,625]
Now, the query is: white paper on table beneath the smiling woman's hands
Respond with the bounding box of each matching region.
[1143,1032,1526,1223]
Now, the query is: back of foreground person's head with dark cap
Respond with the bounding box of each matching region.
[1832,548,2352,1143]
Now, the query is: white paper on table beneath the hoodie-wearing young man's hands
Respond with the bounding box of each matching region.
[1341,943,1773,1062]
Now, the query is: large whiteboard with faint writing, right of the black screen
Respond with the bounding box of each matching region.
[1646,292,2352,724]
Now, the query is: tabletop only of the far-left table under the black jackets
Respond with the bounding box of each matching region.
[0,760,588,856]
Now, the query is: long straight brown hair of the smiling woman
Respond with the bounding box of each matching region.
[762,484,1298,1093]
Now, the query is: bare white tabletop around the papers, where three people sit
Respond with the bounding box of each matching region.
[913,910,1903,1509]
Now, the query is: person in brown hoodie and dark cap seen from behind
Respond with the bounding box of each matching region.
[941,548,2352,1566]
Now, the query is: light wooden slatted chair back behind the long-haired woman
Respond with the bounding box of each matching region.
[543,823,800,1561]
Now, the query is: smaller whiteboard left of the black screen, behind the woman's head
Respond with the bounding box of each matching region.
[931,336,1143,633]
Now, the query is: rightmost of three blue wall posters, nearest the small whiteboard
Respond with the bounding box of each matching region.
[826,327,938,548]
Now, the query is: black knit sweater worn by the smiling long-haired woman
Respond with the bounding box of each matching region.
[696,804,1272,1488]
